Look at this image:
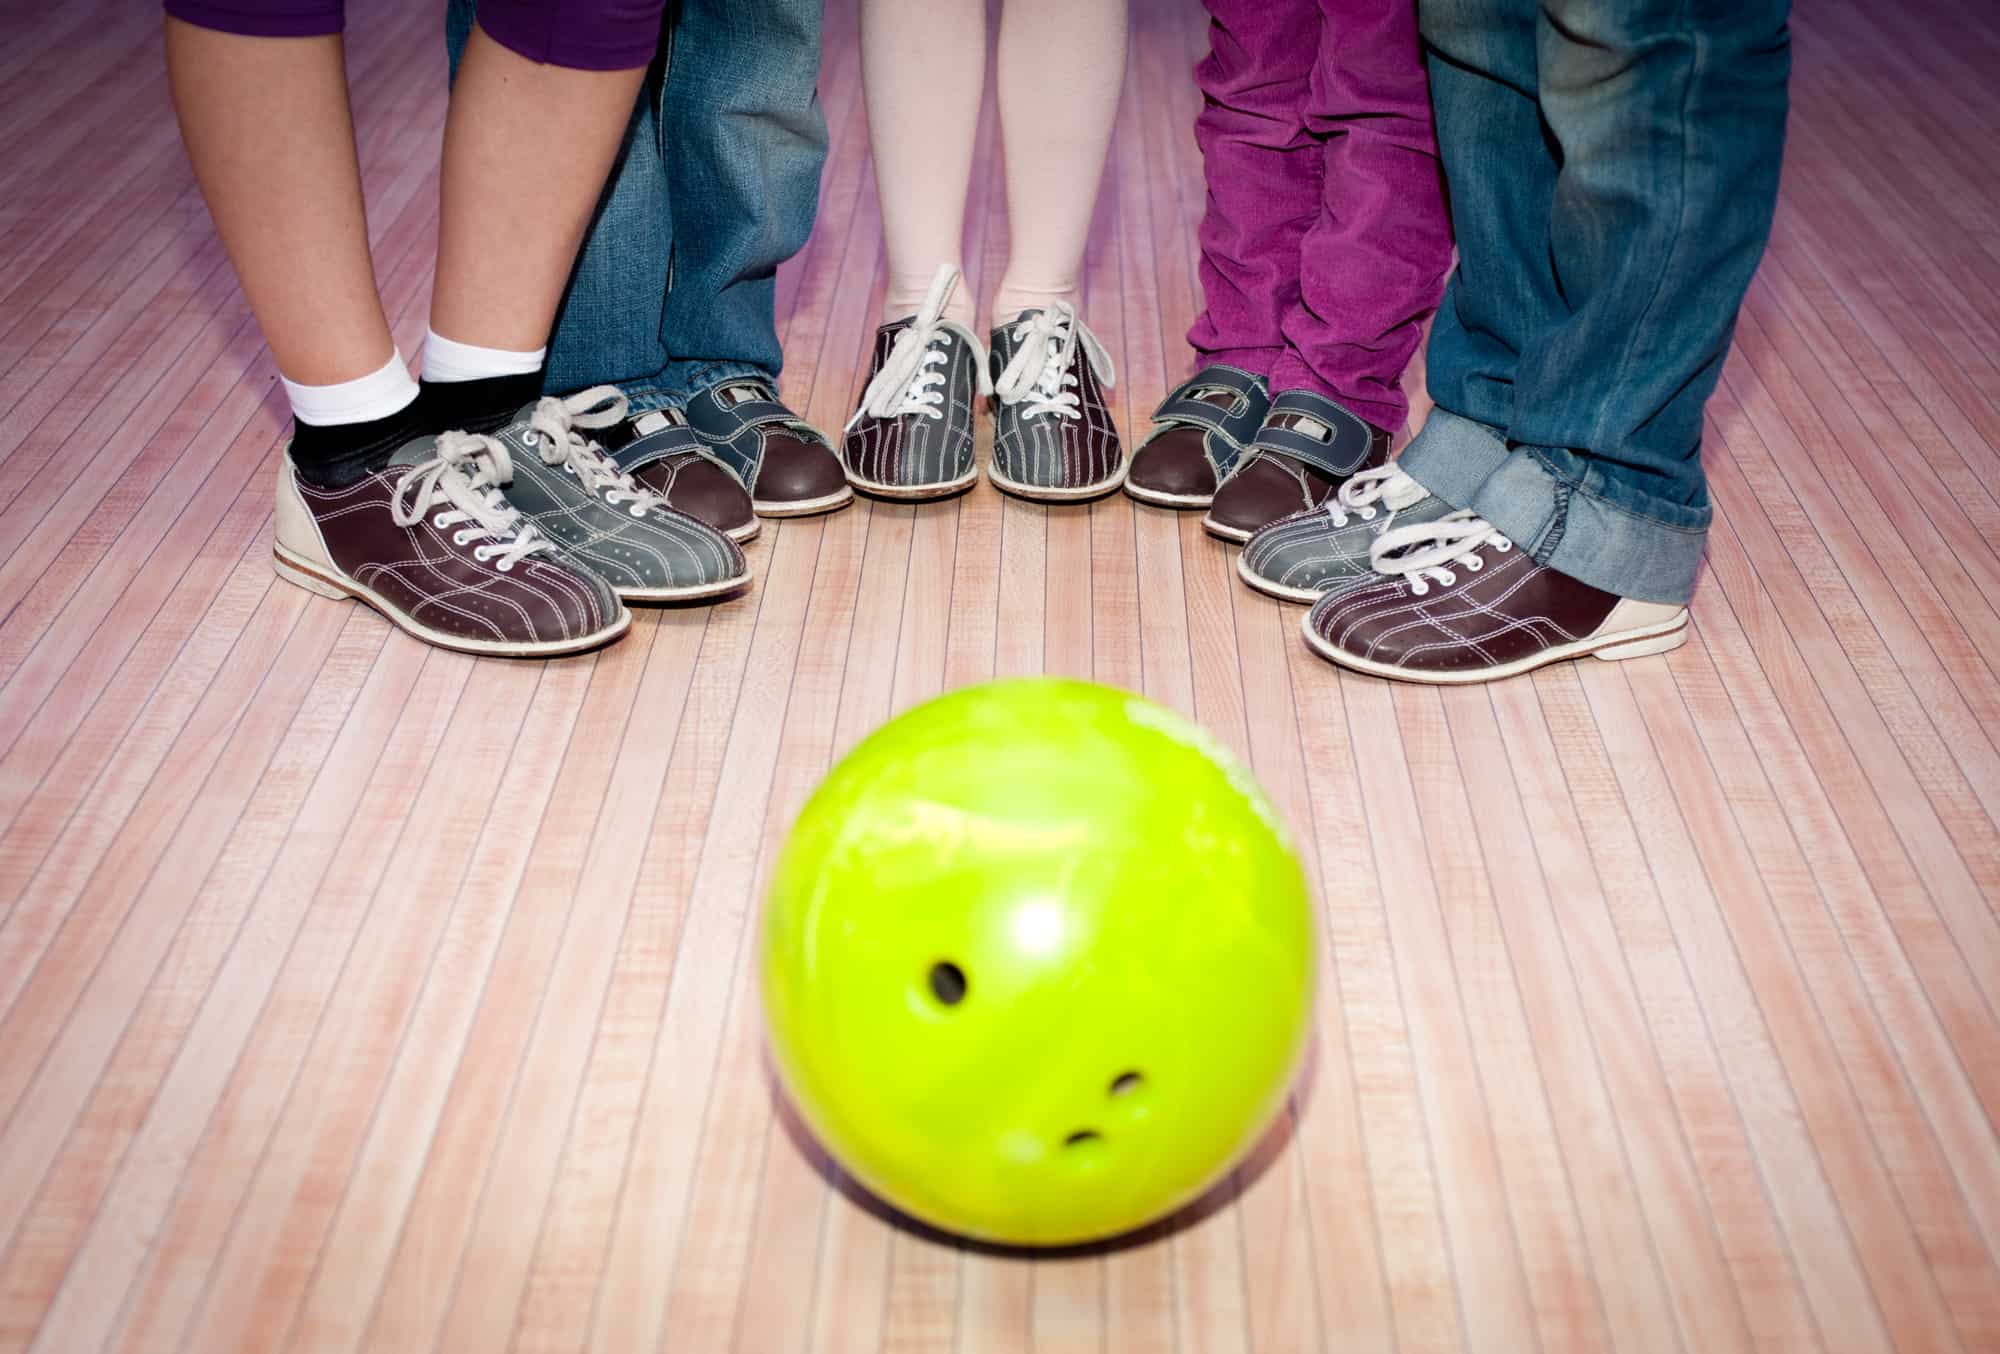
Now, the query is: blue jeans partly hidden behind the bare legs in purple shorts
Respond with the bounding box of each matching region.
[446,0,826,410]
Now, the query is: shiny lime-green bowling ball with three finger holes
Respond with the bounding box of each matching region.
[762,678,1316,1246]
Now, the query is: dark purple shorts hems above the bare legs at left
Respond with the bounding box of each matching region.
[166,0,666,70]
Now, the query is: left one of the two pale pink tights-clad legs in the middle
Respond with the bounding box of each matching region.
[862,0,986,328]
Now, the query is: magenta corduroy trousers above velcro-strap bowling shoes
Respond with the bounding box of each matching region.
[1188,0,1452,430]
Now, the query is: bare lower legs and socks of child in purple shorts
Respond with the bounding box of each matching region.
[166,14,640,484]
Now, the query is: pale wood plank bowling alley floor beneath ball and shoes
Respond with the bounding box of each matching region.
[0,0,2000,1354]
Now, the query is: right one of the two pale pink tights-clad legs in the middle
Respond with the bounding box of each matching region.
[994,0,1126,326]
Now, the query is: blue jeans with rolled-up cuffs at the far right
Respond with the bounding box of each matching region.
[1402,0,1790,602]
